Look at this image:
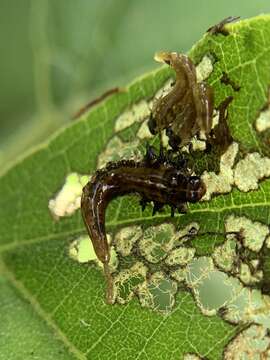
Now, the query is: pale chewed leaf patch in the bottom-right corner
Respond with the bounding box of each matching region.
[224,324,270,360]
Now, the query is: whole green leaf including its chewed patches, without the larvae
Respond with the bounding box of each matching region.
[0,16,270,360]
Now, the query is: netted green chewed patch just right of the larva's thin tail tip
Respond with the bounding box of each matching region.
[113,262,148,304]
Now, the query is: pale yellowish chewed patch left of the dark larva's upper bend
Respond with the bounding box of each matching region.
[48,173,89,219]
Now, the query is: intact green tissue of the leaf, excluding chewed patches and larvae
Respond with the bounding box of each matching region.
[0,16,270,360]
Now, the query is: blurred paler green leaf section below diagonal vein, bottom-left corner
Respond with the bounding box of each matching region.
[0,276,76,360]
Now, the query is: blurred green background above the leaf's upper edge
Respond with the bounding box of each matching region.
[0,0,270,172]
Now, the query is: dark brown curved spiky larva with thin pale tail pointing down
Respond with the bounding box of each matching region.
[81,148,206,303]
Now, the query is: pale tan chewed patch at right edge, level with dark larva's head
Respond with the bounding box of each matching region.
[234,153,270,192]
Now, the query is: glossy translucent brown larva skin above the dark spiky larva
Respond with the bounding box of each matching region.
[149,52,214,147]
